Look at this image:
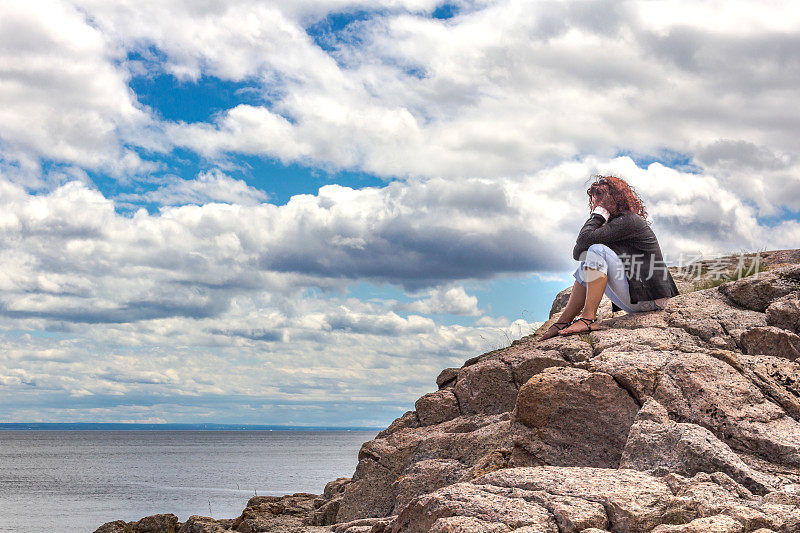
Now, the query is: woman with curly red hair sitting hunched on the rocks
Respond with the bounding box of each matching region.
[540,176,678,340]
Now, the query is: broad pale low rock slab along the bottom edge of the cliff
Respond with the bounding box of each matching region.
[390,466,789,533]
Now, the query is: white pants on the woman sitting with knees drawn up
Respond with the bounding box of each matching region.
[572,244,669,313]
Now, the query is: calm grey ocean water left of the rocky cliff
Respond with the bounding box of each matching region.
[0,430,378,532]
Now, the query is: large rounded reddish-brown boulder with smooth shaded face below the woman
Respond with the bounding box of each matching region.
[513,367,639,467]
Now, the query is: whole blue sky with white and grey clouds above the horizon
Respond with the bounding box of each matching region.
[0,0,800,426]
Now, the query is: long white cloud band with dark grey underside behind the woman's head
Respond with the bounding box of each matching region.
[0,157,797,329]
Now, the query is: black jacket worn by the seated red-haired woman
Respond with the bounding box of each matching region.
[572,211,678,310]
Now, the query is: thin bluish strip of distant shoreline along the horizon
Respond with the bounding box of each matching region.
[0,422,383,431]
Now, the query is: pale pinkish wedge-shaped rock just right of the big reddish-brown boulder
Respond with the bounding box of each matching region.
[620,399,775,494]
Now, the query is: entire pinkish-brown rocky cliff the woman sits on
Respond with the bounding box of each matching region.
[97,250,800,533]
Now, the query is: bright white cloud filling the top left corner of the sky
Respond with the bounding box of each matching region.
[0,0,152,173]
